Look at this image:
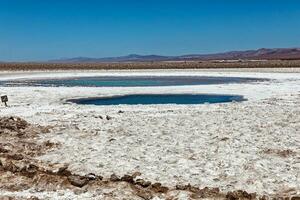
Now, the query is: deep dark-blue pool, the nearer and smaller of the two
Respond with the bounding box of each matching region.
[69,94,246,105]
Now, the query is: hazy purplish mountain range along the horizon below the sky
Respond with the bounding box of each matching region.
[49,48,300,63]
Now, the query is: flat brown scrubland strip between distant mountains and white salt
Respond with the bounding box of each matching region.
[0,60,300,71]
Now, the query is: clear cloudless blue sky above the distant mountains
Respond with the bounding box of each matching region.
[0,0,300,61]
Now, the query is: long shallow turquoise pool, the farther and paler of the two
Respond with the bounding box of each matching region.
[0,76,264,87]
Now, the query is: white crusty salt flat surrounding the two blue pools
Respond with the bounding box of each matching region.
[0,69,300,198]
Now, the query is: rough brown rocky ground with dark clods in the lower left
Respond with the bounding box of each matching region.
[0,117,262,200]
